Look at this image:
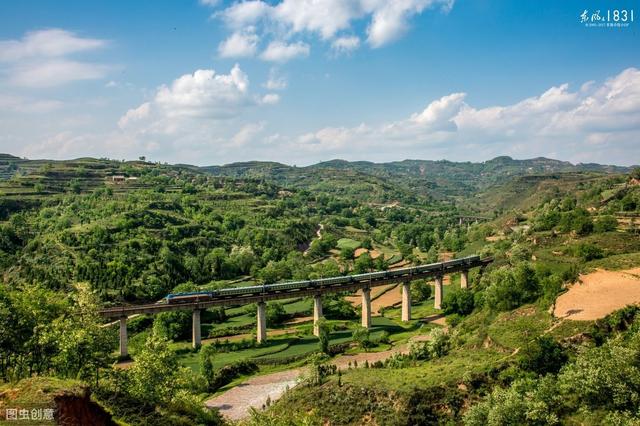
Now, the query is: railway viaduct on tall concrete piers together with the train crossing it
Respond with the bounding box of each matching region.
[99,256,493,357]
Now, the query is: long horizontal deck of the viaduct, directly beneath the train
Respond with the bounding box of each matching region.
[99,258,493,318]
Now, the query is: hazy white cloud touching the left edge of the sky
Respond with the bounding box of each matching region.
[0,29,111,88]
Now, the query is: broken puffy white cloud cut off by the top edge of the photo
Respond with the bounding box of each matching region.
[213,0,453,61]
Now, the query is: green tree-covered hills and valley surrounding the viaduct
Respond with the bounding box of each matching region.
[0,155,640,425]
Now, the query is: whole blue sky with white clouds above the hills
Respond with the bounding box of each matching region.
[0,0,640,165]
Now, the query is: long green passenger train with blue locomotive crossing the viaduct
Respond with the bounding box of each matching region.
[165,256,480,305]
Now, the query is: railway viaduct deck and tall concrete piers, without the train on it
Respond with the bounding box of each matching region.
[99,258,493,357]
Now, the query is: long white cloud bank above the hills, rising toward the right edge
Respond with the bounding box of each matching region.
[283,68,640,164]
